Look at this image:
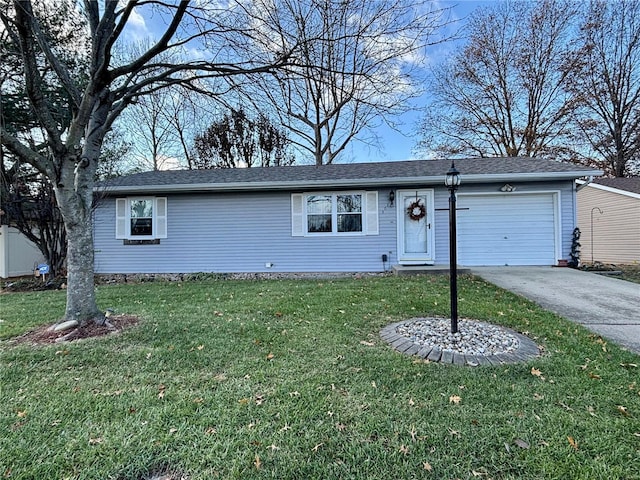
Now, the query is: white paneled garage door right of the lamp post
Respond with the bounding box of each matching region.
[457,193,557,266]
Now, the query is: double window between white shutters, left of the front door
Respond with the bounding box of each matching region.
[306,193,362,233]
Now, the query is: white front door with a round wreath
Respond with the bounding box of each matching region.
[396,190,435,265]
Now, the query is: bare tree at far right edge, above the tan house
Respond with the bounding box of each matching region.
[569,0,640,177]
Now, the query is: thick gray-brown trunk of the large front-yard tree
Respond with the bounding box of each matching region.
[55,154,105,325]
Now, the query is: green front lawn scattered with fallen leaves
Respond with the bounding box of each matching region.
[0,277,640,480]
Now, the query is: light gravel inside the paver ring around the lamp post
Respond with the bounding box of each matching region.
[396,318,520,356]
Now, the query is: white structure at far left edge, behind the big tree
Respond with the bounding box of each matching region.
[0,225,44,278]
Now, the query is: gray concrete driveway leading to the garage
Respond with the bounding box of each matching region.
[471,267,640,354]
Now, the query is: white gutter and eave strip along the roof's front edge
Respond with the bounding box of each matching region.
[94,170,602,195]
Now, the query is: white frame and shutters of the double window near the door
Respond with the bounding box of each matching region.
[291,190,378,238]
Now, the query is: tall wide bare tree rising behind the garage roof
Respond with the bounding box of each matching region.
[417,0,578,161]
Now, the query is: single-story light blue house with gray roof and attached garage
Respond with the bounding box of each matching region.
[94,158,602,273]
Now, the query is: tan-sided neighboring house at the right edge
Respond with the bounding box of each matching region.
[577,177,640,265]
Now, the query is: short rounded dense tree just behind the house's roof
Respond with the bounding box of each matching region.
[193,109,295,169]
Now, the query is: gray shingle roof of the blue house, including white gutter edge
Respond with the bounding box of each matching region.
[97,158,602,193]
